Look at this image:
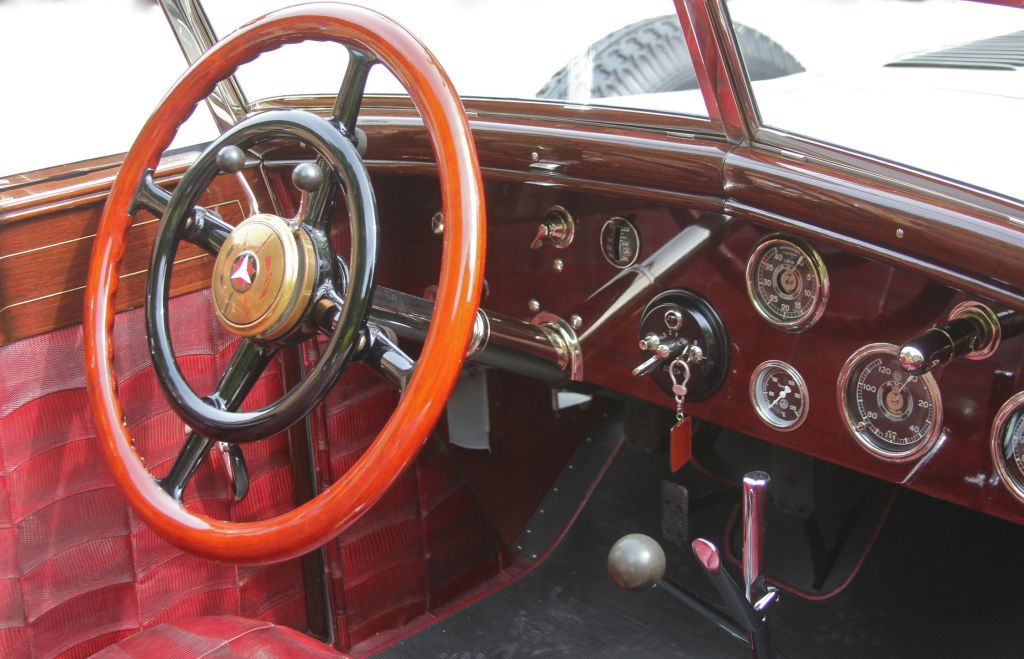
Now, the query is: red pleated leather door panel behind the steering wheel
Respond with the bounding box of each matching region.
[0,293,306,658]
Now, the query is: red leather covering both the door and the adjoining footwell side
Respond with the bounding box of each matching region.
[0,292,502,659]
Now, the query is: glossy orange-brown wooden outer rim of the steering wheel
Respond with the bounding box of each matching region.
[84,3,485,564]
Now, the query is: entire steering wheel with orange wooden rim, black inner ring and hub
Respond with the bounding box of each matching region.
[85,3,484,564]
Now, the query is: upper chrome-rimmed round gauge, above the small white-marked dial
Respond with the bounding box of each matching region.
[746,238,828,332]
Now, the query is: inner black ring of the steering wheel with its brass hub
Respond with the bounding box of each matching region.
[148,112,377,442]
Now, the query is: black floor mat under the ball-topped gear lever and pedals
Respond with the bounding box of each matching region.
[377,442,1024,659]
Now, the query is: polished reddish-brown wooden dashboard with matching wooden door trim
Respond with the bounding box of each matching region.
[0,106,1024,523]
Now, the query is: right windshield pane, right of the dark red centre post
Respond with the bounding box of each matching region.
[727,0,1024,199]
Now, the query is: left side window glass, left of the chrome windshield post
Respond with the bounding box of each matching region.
[0,0,217,180]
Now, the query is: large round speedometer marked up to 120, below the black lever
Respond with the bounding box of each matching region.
[838,343,942,463]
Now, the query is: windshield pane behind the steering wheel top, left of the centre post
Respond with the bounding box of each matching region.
[203,0,708,117]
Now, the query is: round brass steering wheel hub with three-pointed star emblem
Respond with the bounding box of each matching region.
[210,213,316,339]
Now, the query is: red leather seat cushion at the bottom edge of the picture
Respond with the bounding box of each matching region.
[93,616,345,659]
